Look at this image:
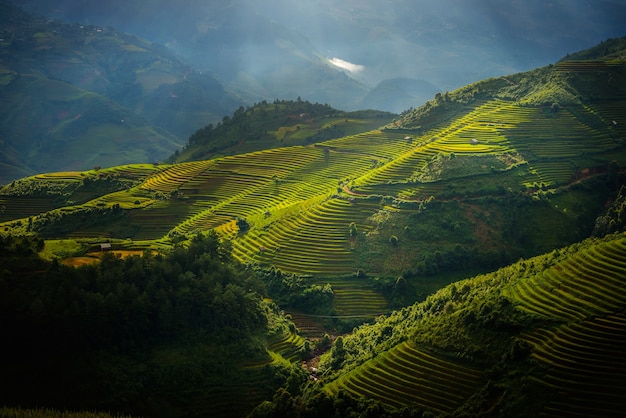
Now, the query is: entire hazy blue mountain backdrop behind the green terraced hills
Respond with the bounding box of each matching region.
[0,0,626,183]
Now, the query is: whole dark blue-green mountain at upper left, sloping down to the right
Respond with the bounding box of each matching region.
[0,1,240,183]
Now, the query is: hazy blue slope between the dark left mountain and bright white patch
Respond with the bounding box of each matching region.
[17,1,367,114]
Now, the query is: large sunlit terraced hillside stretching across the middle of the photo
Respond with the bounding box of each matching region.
[0,40,626,316]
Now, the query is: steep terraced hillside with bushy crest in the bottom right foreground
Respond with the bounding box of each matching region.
[247,233,626,417]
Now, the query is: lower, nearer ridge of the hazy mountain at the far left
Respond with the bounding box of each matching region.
[0,75,178,177]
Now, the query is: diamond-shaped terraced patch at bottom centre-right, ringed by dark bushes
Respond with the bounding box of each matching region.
[324,342,484,413]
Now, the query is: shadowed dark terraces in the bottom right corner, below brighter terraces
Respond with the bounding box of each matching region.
[525,314,626,417]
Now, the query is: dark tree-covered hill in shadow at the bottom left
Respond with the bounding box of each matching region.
[0,234,285,416]
